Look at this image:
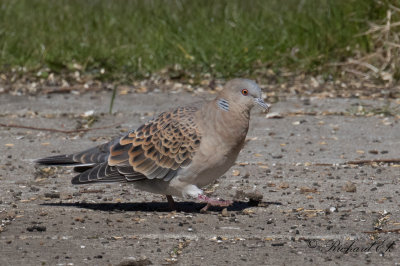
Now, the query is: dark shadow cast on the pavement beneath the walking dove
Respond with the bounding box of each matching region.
[41,201,282,213]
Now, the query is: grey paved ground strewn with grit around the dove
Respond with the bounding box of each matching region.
[0,92,400,265]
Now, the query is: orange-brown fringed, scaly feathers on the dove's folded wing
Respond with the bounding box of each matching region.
[108,107,201,180]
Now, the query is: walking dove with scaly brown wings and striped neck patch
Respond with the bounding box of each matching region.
[36,79,269,211]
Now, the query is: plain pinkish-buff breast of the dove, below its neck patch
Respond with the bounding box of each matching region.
[179,102,249,187]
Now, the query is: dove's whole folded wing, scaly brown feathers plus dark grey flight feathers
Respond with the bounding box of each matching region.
[72,107,201,184]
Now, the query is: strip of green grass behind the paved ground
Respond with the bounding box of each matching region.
[0,0,385,78]
